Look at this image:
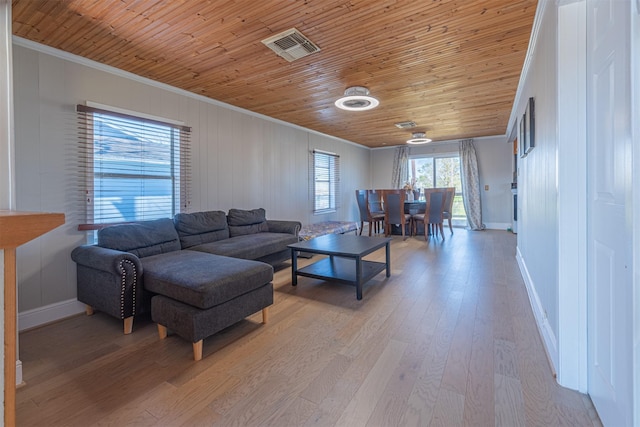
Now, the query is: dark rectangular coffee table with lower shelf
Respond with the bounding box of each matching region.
[288,234,391,300]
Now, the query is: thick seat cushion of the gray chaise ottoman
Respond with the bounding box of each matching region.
[141,250,273,309]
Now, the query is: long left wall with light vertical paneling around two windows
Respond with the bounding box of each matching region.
[13,40,370,328]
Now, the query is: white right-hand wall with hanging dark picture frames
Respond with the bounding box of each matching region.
[514,3,559,374]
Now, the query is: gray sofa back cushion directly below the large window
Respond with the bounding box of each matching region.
[98,218,181,258]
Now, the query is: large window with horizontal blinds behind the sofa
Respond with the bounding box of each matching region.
[76,105,191,230]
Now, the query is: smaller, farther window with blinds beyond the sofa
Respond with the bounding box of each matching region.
[309,150,340,214]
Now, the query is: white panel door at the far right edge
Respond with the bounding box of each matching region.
[587,0,633,426]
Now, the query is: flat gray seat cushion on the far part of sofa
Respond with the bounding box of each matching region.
[189,232,298,259]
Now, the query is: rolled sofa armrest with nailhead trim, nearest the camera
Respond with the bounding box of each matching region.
[71,245,144,319]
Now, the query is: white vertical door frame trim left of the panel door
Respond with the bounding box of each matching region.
[556,2,588,393]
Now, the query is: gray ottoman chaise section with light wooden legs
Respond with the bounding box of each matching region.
[143,250,273,360]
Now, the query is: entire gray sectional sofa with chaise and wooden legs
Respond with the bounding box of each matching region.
[71,209,301,360]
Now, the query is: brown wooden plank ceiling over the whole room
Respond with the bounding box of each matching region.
[12,0,537,147]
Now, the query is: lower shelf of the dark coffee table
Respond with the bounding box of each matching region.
[295,256,387,286]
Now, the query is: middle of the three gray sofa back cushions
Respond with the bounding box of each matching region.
[173,211,229,249]
